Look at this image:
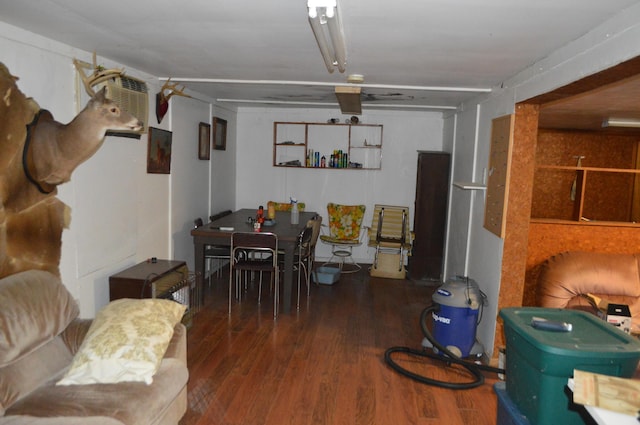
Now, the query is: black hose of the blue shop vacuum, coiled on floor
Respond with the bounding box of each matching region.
[384,306,505,390]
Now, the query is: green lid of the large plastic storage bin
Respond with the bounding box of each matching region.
[500,307,640,358]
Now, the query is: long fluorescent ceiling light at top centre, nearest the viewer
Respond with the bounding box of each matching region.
[307,0,347,73]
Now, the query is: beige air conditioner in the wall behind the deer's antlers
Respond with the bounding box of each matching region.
[95,75,149,134]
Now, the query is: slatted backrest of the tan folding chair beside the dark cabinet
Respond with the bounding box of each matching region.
[369,204,411,246]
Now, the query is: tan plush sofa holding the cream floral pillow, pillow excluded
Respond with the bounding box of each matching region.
[0,270,189,425]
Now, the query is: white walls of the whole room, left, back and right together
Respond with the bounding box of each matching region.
[5,5,640,350]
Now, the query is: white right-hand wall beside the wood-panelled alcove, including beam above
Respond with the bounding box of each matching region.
[448,5,640,355]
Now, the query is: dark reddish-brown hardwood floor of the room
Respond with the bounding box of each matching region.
[180,270,497,425]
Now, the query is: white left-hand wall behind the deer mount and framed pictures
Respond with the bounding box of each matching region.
[0,23,235,317]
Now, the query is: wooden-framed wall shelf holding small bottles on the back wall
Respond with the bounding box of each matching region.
[273,122,382,170]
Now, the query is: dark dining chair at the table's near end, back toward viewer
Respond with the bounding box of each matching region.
[229,232,280,319]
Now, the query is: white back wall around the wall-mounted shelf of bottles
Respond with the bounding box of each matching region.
[236,108,443,263]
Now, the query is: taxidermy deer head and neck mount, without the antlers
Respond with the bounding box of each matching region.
[22,88,143,193]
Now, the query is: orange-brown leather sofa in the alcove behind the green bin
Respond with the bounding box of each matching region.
[537,251,640,334]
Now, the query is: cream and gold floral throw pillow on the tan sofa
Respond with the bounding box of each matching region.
[57,298,186,385]
